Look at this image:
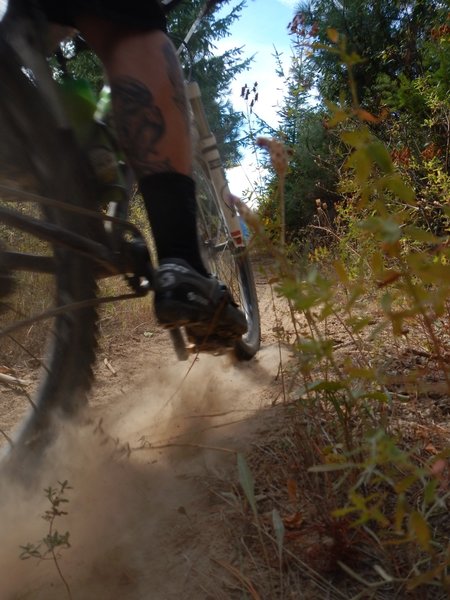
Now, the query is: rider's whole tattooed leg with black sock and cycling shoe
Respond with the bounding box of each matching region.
[76,15,247,340]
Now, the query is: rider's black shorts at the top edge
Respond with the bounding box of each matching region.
[39,0,166,31]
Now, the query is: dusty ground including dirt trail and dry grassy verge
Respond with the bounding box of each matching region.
[0,262,450,600]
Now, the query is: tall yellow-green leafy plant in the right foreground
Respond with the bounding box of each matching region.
[243,30,450,594]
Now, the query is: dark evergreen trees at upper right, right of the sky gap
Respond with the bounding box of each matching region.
[262,0,450,243]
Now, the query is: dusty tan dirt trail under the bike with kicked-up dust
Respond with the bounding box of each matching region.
[0,266,296,600]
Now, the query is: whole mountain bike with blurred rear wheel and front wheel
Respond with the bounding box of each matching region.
[0,1,260,458]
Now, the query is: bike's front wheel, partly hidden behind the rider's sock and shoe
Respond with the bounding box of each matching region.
[195,165,261,361]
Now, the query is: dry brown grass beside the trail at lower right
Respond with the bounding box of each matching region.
[210,282,450,600]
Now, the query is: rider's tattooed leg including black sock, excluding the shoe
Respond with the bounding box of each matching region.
[76,15,207,275]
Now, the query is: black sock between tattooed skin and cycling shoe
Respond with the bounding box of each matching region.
[139,172,208,276]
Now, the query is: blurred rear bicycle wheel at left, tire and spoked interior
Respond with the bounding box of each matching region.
[0,36,99,460]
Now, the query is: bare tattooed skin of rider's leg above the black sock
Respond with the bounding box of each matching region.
[78,16,192,179]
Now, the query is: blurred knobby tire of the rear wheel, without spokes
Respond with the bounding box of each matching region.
[0,37,98,462]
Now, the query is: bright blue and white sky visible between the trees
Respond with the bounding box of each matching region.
[218,0,299,195]
